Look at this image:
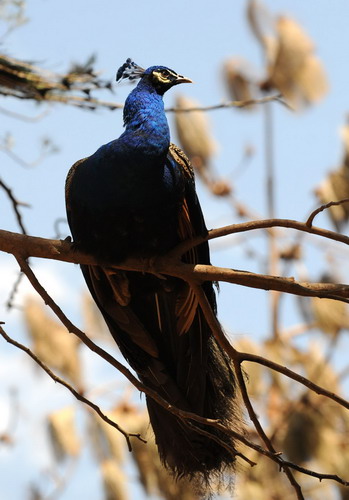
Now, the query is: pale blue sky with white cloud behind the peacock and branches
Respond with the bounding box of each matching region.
[0,0,349,500]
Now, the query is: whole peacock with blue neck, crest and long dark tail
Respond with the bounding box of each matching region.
[66,60,236,486]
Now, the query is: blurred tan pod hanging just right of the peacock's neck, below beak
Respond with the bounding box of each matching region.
[175,95,217,170]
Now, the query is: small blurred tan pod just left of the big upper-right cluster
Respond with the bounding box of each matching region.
[223,58,256,110]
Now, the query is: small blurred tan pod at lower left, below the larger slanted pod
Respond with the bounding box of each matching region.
[47,406,80,461]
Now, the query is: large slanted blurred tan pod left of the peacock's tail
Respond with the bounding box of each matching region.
[24,297,81,385]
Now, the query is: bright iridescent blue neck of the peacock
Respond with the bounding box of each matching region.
[119,80,170,157]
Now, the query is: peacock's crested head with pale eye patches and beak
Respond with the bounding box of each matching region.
[116,59,193,95]
